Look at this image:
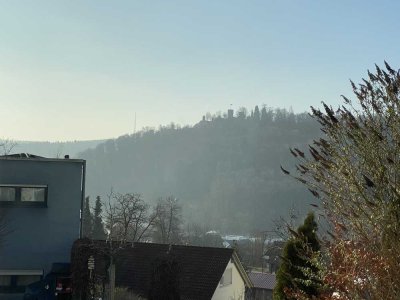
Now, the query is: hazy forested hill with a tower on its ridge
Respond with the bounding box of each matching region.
[79,107,320,232]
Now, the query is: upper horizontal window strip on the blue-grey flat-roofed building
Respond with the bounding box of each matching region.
[0,184,47,207]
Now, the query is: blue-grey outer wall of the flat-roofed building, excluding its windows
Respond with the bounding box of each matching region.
[0,158,84,274]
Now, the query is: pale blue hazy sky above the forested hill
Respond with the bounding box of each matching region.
[0,0,400,141]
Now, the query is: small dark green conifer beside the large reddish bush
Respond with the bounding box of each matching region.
[274,213,321,300]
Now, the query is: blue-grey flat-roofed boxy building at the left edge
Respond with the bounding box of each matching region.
[0,154,85,299]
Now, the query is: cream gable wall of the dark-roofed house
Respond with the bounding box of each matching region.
[212,261,245,300]
